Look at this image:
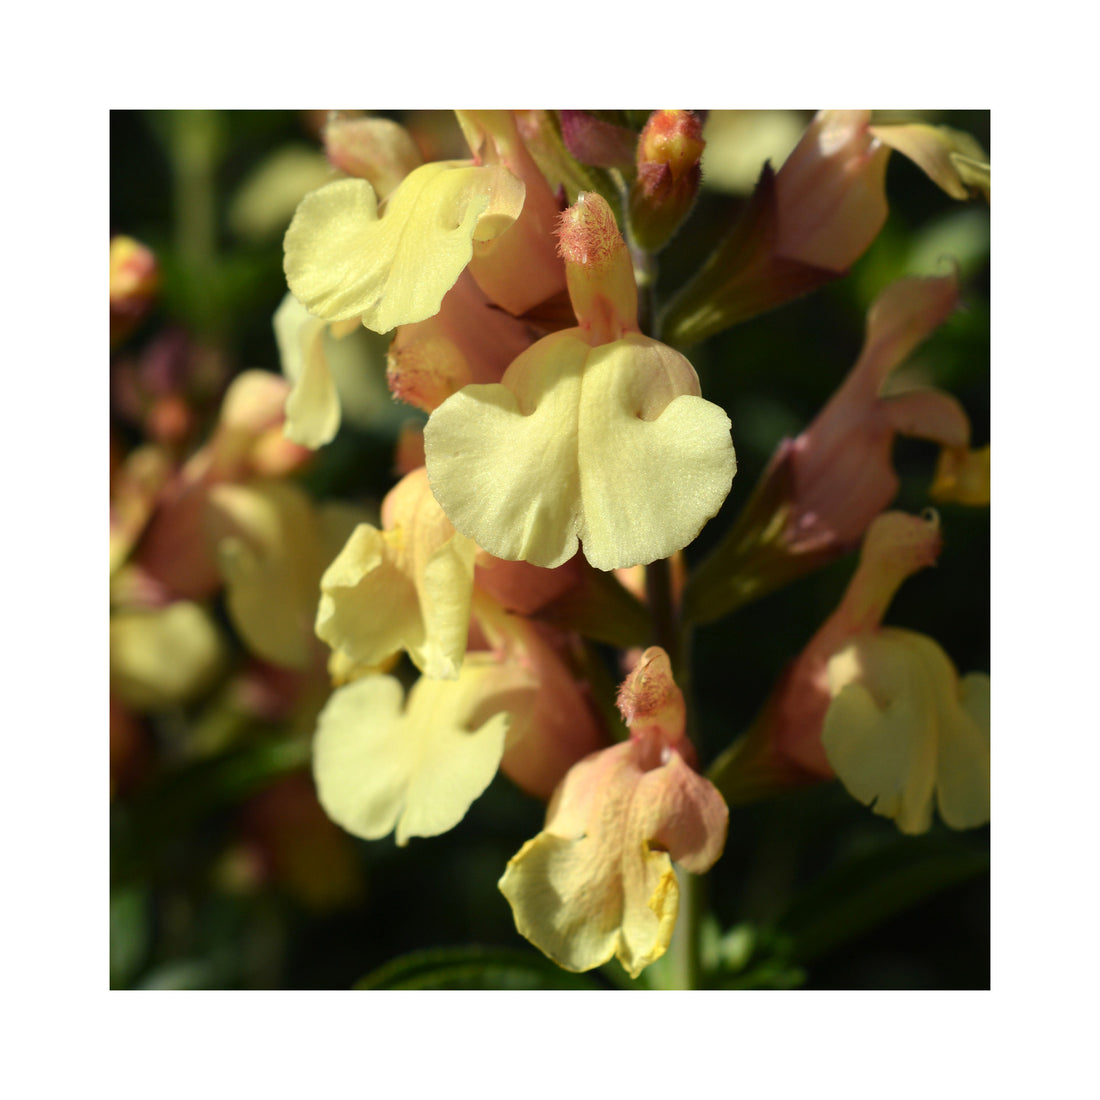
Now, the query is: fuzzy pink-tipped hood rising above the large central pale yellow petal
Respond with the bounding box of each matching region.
[558,191,638,344]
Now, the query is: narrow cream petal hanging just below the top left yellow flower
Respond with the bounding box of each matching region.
[274,294,340,450]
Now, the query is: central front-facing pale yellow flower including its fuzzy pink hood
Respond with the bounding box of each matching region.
[425,196,736,570]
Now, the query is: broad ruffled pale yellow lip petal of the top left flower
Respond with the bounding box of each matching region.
[284,161,524,332]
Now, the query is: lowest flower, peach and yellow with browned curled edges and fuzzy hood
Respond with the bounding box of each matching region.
[499,649,728,978]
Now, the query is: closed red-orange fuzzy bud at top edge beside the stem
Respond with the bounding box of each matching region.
[630,111,705,252]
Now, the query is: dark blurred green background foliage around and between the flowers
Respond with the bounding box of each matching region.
[110,111,990,989]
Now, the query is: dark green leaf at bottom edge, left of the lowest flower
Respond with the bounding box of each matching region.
[355,946,603,989]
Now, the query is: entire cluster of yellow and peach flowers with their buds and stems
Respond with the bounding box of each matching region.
[111,111,990,979]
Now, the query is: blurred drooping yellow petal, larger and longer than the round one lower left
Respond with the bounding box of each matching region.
[206,481,361,669]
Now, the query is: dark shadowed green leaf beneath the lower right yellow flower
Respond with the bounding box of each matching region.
[778,836,989,963]
